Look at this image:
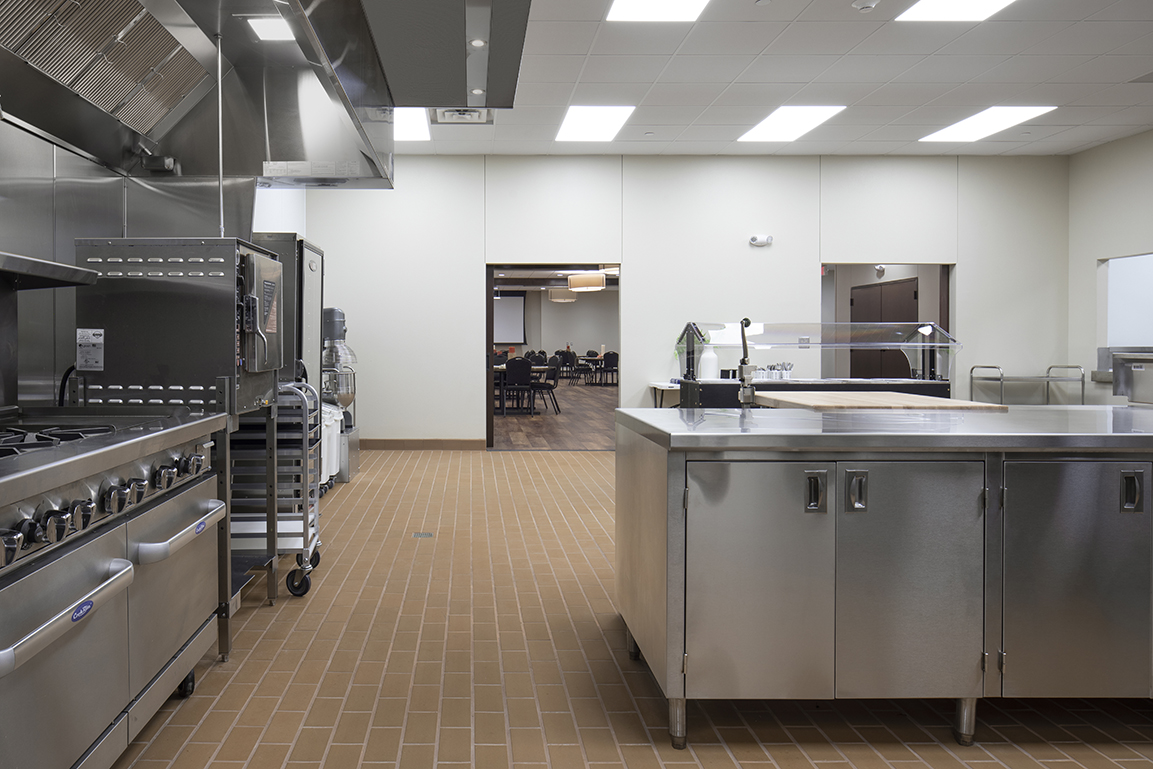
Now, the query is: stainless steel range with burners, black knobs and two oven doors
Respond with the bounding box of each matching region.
[0,256,227,769]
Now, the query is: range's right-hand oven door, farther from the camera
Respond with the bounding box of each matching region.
[127,477,223,696]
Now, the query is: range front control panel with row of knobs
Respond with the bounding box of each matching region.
[0,438,213,574]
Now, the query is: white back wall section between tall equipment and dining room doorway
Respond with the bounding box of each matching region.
[308,156,490,439]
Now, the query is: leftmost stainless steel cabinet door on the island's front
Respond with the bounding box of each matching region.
[685,462,835,699]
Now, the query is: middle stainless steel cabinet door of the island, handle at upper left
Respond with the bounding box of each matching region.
[836,462,985,698]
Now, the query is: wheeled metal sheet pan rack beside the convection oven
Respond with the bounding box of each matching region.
[232,382,322,602]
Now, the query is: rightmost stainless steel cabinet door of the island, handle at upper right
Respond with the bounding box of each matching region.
[1003,461,1151,698]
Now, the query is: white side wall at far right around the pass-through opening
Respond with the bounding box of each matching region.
[1067,126,1153,402]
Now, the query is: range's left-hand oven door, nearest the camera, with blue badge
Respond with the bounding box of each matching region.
[0,526,134,767]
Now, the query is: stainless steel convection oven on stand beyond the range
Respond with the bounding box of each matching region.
[76,238,285,414]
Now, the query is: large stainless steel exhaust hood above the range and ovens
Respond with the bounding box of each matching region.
[0,0,393,188]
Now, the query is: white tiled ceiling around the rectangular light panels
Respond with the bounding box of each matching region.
[397,0,1153,154]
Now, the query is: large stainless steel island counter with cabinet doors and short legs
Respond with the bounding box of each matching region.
[616,405,1153,747]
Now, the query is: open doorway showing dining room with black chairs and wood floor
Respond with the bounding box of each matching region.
[487,264,620,451]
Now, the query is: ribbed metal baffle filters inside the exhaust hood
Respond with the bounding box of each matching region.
[0,0,208,134]
